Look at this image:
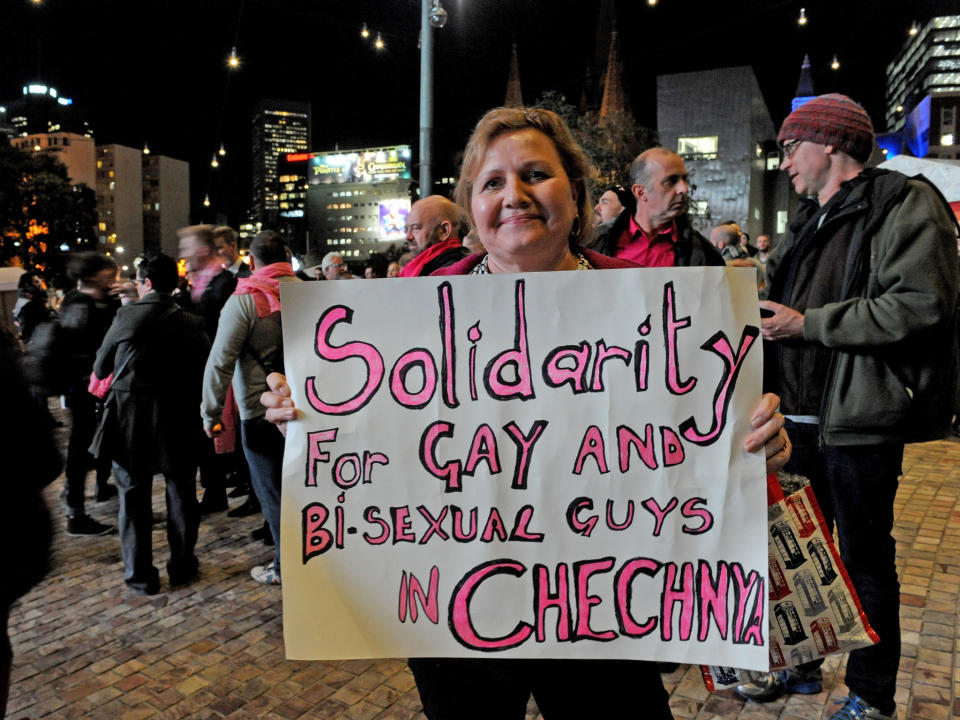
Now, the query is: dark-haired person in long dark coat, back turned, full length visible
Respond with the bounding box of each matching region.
[90,255,210,595]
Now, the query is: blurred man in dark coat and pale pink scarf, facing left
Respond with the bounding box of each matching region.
[177,225,237,515]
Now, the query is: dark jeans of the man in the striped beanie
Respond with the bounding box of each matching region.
[784,420,903,713]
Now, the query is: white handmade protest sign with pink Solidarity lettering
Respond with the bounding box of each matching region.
[281,268,768,669]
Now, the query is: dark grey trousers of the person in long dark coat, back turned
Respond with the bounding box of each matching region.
[113,463,200,590]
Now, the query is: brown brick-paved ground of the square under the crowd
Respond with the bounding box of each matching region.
[7,428,960,720]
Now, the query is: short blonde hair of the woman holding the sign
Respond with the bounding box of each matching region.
[454,107,593,245]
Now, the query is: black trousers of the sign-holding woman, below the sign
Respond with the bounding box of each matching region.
[407,658,673,720]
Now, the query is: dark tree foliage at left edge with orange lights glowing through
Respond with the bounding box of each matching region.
[0,143,97,268]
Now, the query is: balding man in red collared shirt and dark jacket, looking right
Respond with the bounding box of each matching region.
[596,147,724,267]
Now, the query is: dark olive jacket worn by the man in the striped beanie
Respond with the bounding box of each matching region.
[765,170,958,445]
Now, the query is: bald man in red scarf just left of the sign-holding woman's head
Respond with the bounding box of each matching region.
[400,195,470,277]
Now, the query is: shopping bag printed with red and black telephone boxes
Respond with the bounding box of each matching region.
[700,474,880,690]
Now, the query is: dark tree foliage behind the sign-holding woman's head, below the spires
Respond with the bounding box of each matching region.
[536,90,658,191]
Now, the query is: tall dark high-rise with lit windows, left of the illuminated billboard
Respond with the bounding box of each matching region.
[250,100,310,225]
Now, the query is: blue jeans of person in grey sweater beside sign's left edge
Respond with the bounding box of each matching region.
[240,417,283,574]
